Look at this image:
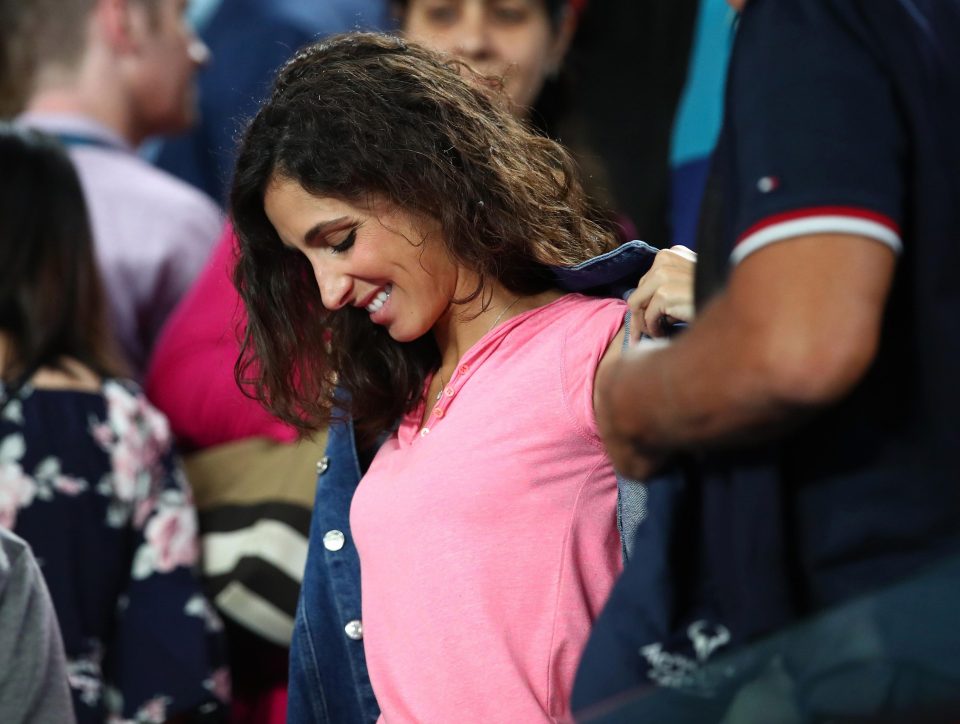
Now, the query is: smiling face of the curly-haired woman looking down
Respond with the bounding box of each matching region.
[264,177,464,342]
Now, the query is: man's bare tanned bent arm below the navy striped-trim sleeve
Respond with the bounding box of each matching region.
[597,234,896,479]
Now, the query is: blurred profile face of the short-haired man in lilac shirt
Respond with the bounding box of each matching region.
[130,0,209,136]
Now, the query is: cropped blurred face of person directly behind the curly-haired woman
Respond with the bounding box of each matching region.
[393,0,576,117]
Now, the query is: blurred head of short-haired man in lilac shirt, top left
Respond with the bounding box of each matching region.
[15,0,208,144]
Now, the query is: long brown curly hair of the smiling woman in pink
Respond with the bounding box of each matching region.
[230,33,614,441]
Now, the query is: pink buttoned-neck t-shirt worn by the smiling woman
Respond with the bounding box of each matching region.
[350,294,626,724]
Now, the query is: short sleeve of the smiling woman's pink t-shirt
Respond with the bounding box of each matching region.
[560,298,627,443]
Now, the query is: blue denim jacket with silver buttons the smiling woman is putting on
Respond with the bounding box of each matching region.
[287,241,657,724]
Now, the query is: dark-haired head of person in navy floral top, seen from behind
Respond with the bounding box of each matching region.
[0,123,120,383]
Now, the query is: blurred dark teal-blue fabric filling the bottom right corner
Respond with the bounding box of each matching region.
[578,556,960,724]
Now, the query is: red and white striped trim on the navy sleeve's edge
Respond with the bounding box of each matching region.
[730,206,903,264]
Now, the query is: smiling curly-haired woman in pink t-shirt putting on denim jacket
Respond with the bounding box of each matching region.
[231,34,656,722]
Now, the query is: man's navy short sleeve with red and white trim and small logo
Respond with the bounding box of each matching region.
[727,0,906,263]
